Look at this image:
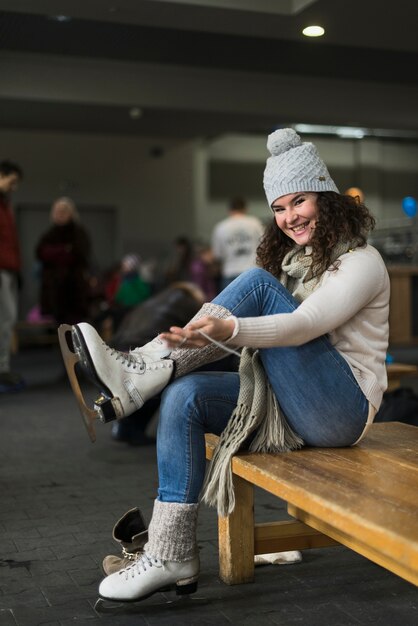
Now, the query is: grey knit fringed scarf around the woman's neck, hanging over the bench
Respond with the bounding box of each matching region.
[202,243,355,517]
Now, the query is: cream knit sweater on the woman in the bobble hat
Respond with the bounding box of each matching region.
[228,245,390,411]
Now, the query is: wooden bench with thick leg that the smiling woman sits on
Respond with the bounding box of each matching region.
[206,422,418,585]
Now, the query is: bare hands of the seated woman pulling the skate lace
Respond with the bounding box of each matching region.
[159,315,235,349]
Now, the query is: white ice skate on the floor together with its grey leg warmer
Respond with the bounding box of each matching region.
[99,500,200,602]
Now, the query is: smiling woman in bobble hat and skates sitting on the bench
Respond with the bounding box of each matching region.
[60,129,389,601]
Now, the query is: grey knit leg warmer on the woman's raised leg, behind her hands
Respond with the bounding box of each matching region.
[170,302,232,378]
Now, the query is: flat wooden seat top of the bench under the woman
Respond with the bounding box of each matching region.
[207,422,418,584]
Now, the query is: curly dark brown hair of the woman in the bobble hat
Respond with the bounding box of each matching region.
[257,191,375,278]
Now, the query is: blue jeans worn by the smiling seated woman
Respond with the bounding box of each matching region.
[157,269,369,503]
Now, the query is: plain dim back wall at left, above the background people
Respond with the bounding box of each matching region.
[0,131,195,256]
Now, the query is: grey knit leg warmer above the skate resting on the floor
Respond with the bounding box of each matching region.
[144,500,199,563]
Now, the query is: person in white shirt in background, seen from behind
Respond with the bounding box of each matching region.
[212,197,264,289]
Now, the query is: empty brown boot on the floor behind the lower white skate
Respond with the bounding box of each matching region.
[102,508,148,576]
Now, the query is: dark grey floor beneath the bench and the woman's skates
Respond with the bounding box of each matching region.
[0,348,418,626]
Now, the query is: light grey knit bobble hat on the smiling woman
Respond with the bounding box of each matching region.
[263,128,339,207]
